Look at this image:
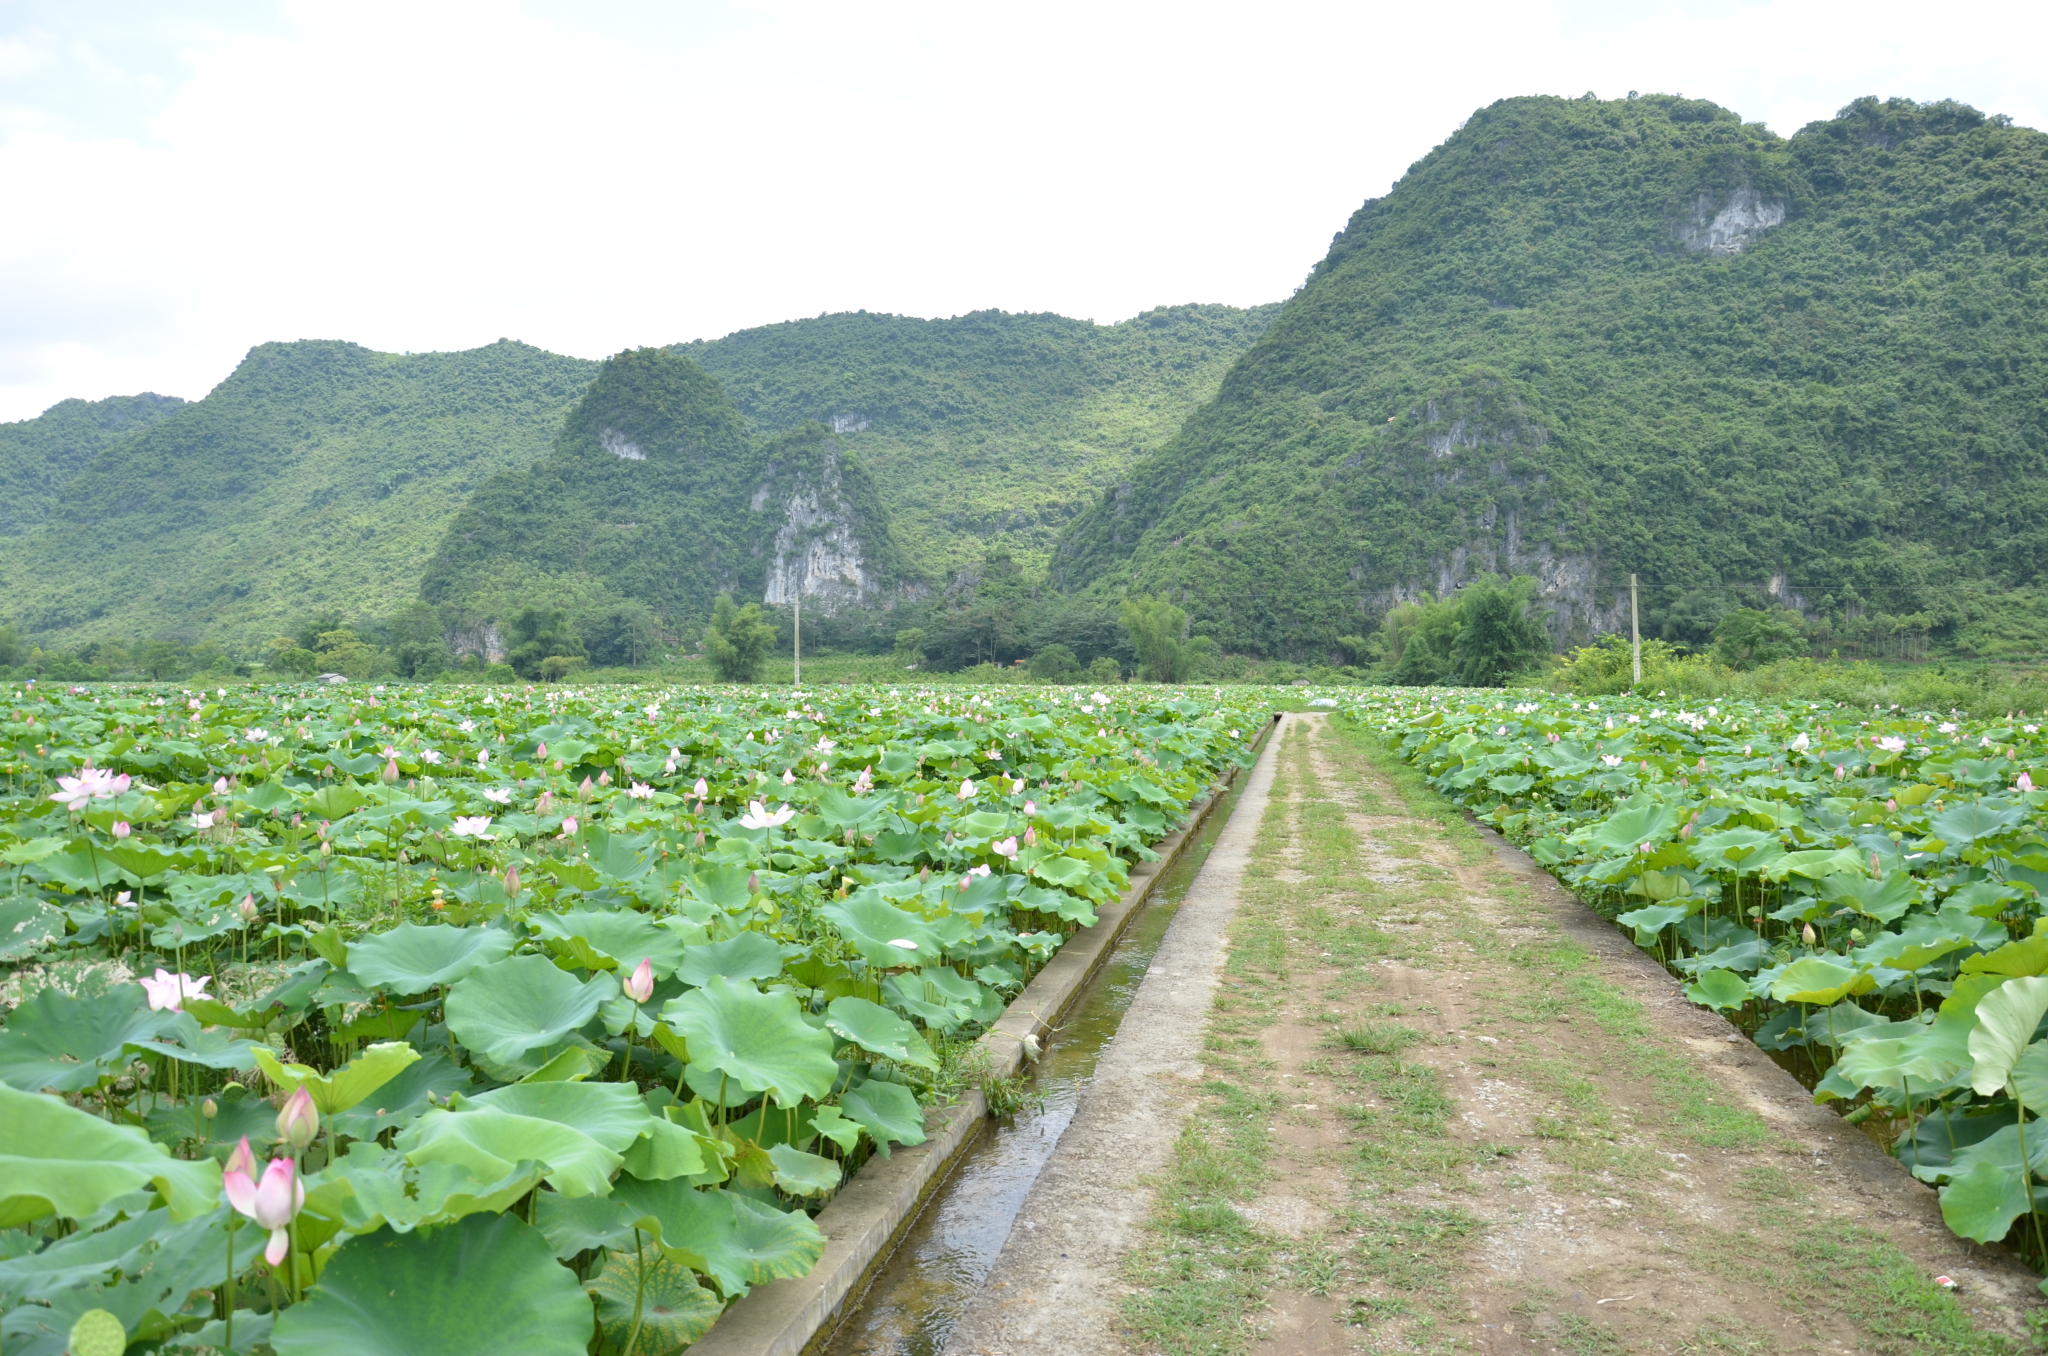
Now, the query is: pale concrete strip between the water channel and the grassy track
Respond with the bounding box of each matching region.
[946,704,1276,1356]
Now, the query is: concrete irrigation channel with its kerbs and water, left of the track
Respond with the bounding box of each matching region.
[690,717,1286,1356]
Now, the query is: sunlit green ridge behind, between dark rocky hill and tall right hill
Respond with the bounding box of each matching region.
[682,305,1280,584]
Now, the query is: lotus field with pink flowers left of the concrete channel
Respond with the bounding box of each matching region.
[0,684,1269,1356]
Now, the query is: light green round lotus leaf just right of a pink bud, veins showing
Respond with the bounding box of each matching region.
[662,975,840,1106]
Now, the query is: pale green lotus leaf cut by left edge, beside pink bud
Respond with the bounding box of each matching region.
[0,1086,221,1229]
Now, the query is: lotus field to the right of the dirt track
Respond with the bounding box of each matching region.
[1348,690,2048,1264]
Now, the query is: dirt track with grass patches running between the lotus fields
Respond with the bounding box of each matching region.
[1122,719,2038,1356]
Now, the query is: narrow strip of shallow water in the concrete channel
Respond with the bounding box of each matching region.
[821,776,1249,1356]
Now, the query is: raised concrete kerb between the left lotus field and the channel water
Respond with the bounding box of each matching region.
[690,715,1280,1356]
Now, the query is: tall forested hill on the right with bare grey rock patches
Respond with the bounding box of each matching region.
[1055,96,2048,655]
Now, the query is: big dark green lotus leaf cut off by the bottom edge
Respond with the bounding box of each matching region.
[270,1215,592,1356]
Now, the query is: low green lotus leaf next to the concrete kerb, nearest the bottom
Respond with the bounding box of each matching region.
[616,1178,825,1295]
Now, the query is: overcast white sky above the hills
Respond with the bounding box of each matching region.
[0,0,2048,420]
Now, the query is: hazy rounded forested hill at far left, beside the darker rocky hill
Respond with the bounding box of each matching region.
[0,342,598,653]
